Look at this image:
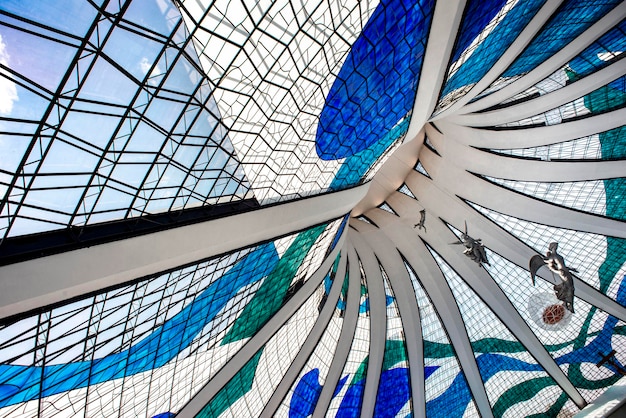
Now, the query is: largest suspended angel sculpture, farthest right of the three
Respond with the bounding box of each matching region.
[529,242,578,313]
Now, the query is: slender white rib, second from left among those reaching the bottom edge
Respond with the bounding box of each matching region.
[260,248,347,418]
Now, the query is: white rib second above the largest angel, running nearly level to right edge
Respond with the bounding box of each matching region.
[425,124,626,182]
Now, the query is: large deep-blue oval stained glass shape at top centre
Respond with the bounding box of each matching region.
[316,0,434,160]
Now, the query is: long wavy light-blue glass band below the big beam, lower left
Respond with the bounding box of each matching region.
[0,243,278,407]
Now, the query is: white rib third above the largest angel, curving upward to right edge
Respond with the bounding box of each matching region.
[437,108,626,149]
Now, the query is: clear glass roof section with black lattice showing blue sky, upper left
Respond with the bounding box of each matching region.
[0,1,252,238]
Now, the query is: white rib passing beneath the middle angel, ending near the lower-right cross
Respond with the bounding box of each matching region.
[420,219,586,409]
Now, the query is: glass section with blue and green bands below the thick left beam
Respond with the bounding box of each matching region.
[0,221,339,414]
